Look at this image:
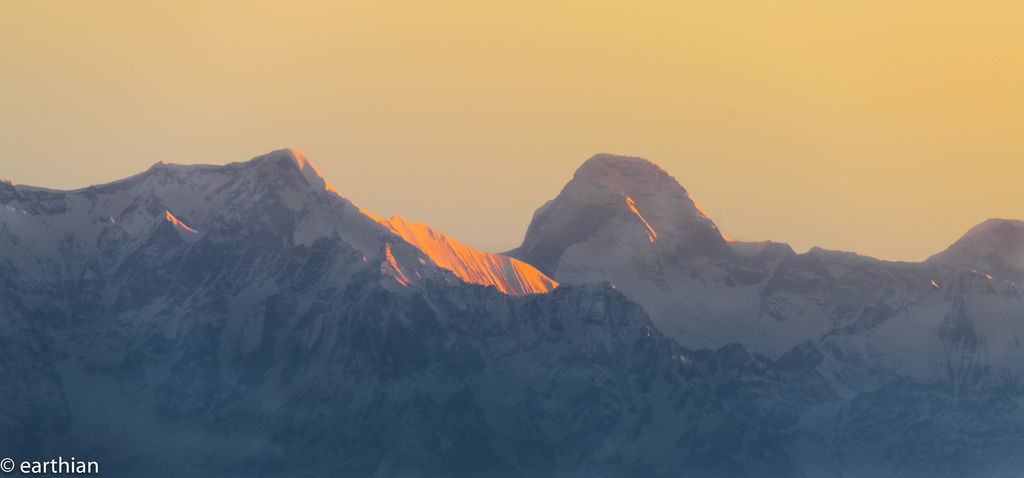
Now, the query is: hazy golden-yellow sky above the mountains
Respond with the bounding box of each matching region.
[0,0,1024,260]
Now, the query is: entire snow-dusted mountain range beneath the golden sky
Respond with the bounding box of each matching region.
[0,149,1024,477]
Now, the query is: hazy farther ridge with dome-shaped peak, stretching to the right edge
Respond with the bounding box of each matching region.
[508,155,1024,376]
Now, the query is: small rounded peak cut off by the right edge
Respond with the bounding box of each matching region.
[928,218,1024,272]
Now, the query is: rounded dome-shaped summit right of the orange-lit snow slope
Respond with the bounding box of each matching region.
[509,155,729,280]
